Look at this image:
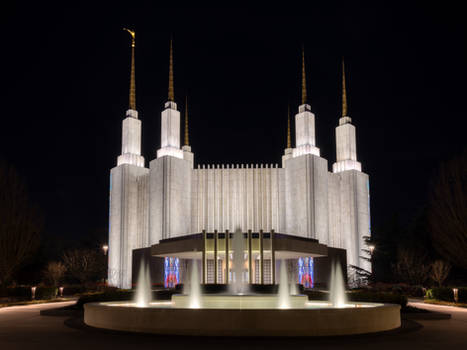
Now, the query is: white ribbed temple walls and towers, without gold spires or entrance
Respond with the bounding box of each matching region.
[109,102,371,288]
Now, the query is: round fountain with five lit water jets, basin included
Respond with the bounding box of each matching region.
[84,232,400,336]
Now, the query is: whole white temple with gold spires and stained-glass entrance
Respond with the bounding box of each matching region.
[108,31,371,288]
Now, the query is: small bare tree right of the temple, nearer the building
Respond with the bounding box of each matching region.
[394,248,430,285]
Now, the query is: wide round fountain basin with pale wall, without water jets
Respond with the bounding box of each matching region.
[84,295,401,336]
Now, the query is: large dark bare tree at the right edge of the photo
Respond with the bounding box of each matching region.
[429,152,467,269]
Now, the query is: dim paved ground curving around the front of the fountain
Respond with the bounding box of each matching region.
[0,302,467,350]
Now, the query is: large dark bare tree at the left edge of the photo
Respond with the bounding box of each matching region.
[0,161,43,285]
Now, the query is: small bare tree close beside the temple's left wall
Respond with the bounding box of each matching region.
[63,249,105,283]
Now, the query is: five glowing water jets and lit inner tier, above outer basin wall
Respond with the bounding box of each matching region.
[133,234,358,309]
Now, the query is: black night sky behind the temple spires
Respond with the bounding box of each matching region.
[0,1,467,243]
